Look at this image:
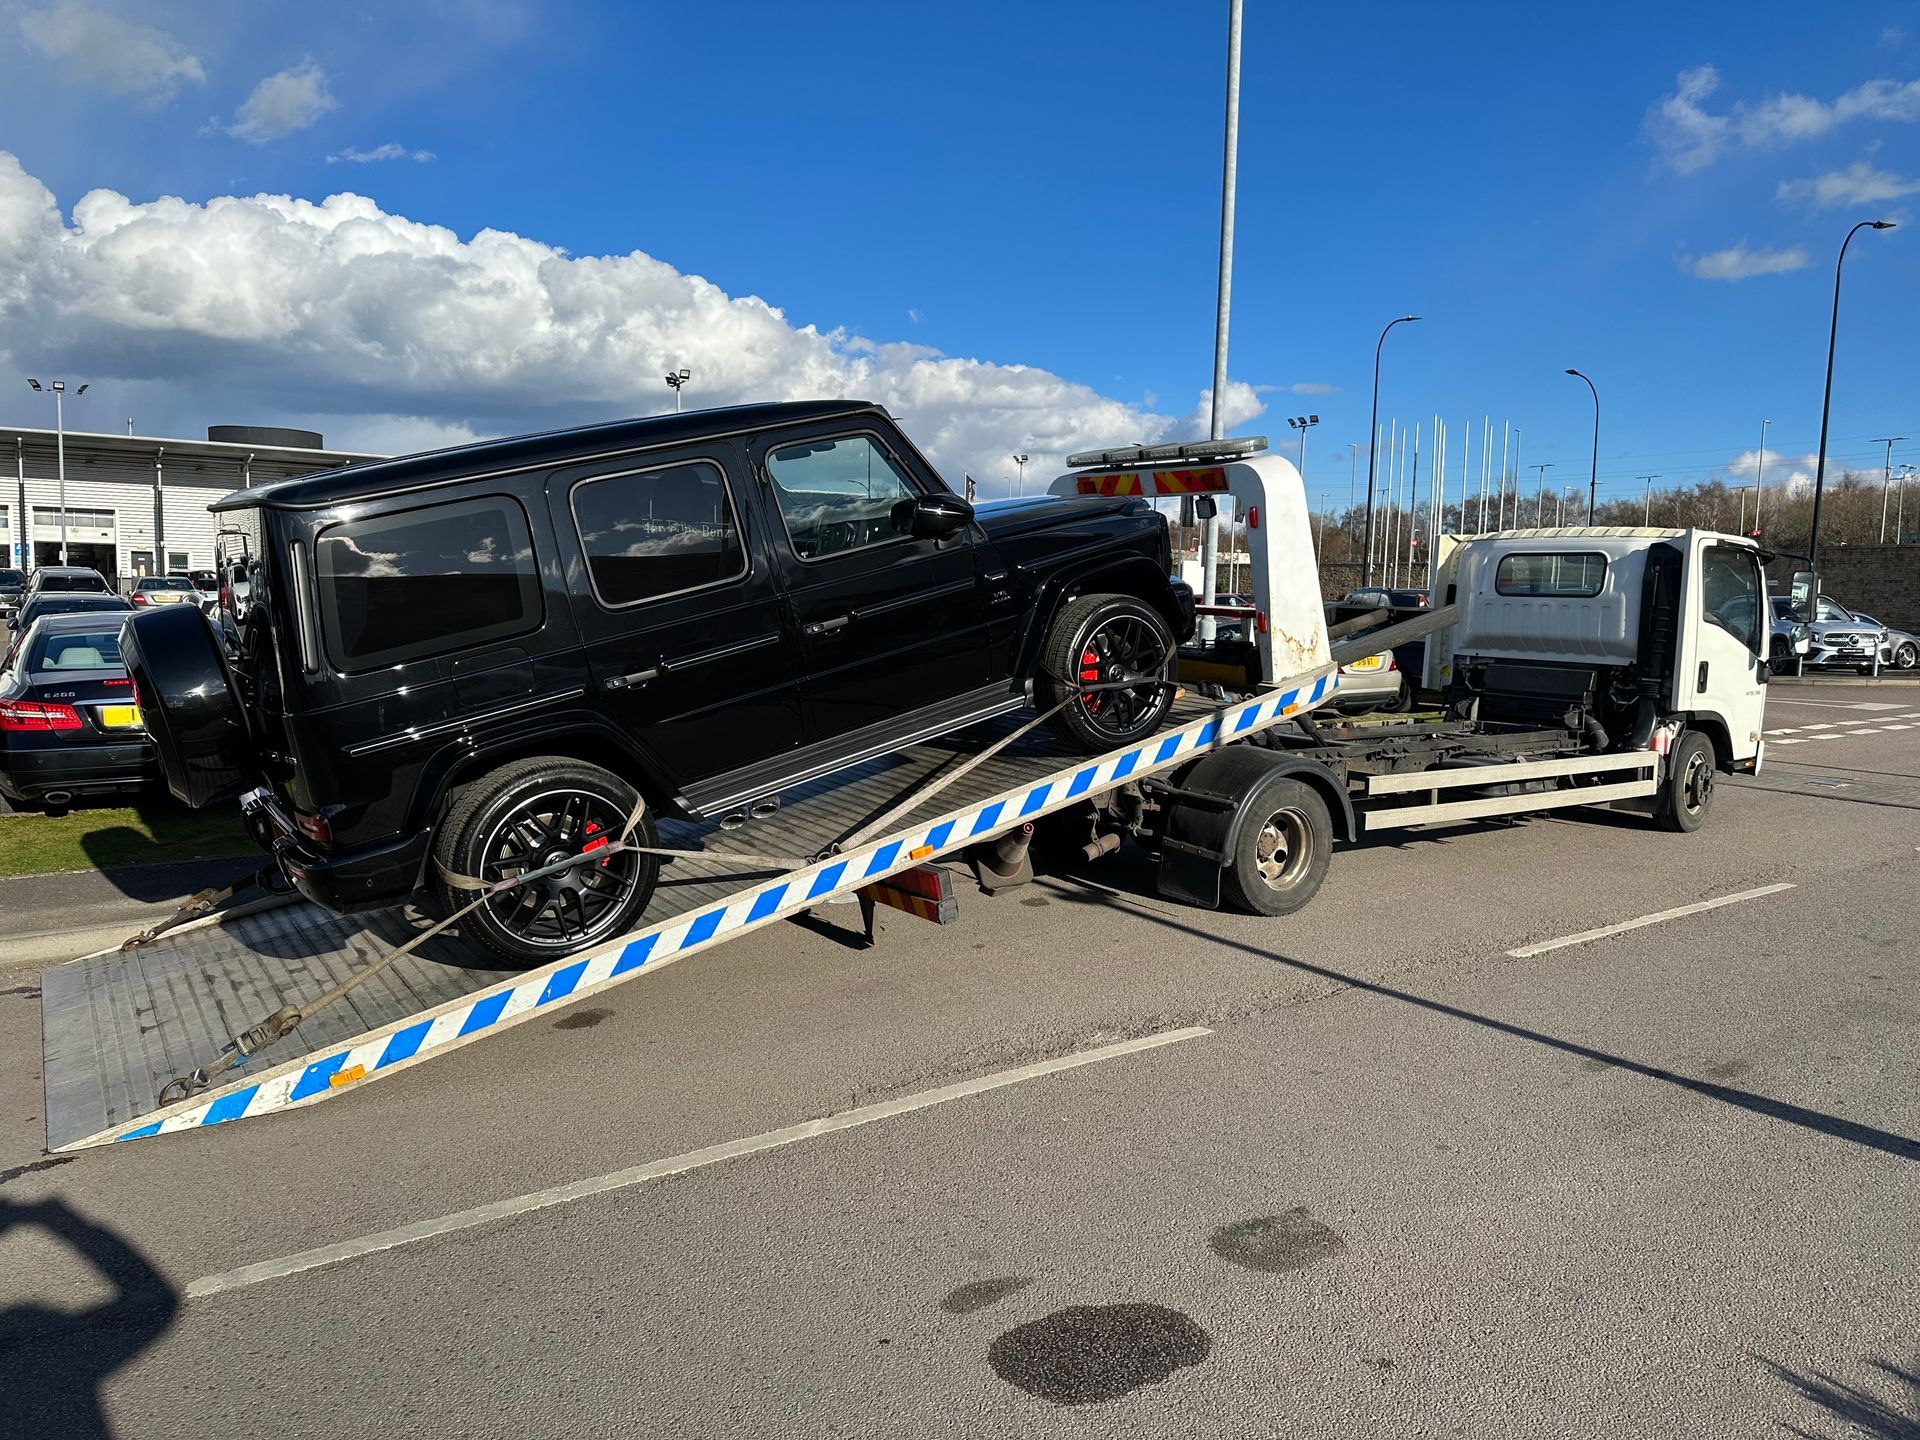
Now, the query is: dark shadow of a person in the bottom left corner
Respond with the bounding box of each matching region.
[0,1200,180,1440]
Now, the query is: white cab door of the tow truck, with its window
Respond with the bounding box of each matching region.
[1676,536,1770,762]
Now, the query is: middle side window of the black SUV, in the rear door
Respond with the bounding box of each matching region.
[572,461,747,607]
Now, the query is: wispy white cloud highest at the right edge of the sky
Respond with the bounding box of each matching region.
[1642,65,1920,175]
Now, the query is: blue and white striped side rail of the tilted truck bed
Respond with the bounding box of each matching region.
[71,672,1338,1150]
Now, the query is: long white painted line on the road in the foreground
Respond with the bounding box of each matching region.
[186,1025,1213,1300]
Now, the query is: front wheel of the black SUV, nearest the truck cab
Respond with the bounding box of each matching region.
[1033,595,1173,755]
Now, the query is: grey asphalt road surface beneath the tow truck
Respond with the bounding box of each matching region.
[0,684,1920,1438]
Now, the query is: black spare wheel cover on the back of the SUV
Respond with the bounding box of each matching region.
[121,605,259,810]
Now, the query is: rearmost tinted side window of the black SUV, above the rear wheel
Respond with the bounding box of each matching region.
[315,495,541,674]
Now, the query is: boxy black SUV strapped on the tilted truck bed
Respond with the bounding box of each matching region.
[125,401,1192,962]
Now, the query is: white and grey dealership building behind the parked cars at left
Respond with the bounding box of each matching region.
[0,424,378,588]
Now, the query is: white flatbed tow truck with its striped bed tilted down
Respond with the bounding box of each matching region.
[42,440,1768,1152]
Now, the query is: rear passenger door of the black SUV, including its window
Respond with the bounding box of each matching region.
[547,442,801,785]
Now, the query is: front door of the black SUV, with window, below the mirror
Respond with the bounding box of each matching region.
[753,430,991,741]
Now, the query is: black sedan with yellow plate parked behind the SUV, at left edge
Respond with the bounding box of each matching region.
[0,611,157,812]
